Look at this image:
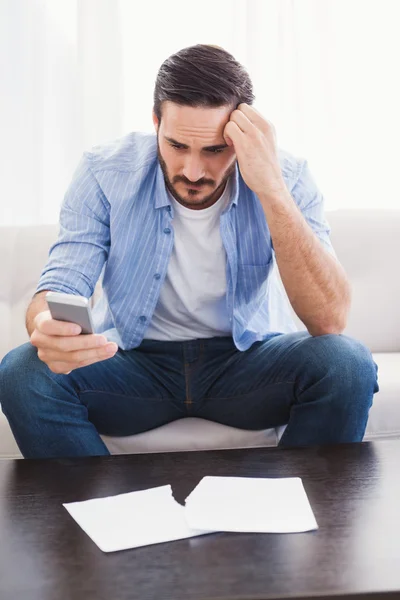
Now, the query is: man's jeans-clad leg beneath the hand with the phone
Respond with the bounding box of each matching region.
[0,343,188,456]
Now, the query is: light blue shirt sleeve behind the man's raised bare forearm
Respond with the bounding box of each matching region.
[291,160,337,258]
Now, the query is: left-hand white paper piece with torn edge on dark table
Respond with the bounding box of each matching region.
[63,485,210,552]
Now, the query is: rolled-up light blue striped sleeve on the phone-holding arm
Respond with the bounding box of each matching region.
[35,153,110,298]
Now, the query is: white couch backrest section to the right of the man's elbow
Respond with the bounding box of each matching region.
[283,210,400,352]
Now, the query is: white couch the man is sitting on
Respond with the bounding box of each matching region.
[0,210,400,458]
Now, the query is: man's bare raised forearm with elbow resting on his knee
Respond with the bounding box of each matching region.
[260,192,351,335]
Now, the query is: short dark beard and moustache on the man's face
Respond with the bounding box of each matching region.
[157,135,236,210]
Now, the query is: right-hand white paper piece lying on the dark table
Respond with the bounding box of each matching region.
[185,477,318,533]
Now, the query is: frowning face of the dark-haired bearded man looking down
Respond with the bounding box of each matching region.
[153,102,236,210]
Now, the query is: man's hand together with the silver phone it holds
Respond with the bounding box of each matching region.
[30,292,118,375]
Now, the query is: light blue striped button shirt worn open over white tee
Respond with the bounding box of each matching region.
[36,132,335,351]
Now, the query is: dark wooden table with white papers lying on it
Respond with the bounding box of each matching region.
[0,441,400,600]
